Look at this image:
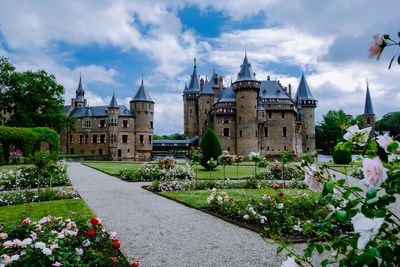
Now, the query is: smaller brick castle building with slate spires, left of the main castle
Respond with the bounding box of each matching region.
[60,78,154,160]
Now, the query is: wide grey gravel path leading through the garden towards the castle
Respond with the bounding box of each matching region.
[68,163,326,266]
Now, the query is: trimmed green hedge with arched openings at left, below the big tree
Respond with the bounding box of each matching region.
[0,126,60,159]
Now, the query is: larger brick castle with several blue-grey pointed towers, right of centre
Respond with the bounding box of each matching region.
[183,53,317,157]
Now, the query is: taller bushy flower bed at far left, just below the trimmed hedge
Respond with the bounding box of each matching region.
[0,161,71,190]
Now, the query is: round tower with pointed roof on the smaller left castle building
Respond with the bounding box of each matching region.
[130,78,154,160]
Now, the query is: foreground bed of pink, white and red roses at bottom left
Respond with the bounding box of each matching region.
[0,213,139,266]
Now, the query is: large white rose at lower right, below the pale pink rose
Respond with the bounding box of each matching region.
[351,213,385,249]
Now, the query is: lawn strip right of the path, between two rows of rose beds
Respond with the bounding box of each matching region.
[160,189,320,208]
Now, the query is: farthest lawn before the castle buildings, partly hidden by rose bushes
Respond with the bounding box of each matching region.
[84,161,261,179]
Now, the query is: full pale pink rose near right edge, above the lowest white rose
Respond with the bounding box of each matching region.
[362,157,387,187]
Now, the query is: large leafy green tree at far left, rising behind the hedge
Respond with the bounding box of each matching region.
[0,57,67,132]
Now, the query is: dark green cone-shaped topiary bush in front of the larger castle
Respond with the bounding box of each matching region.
[200,128,222,170]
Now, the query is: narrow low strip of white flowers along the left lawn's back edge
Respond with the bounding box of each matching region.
[0,187,79,207]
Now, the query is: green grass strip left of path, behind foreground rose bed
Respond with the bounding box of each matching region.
[0,199,93,227]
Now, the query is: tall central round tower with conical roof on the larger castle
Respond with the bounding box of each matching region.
[232,54,261,157]
